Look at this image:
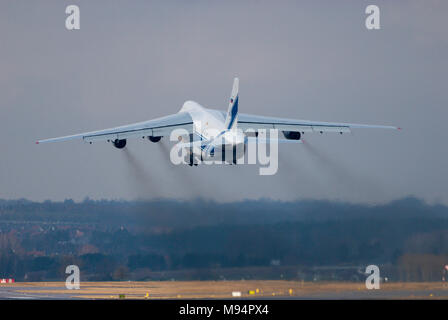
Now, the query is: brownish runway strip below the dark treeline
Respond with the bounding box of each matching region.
[0,280,448,300]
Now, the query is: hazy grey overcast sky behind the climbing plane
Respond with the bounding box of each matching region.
[0,0,448,203]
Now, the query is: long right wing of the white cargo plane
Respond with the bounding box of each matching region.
[238,113,400,133]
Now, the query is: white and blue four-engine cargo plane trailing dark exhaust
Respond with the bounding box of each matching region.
[36,78,400,166]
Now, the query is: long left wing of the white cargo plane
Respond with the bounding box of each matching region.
[36,112,193,144]
